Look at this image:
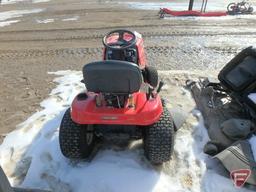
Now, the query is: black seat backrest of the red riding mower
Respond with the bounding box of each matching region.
[83,60,142,94]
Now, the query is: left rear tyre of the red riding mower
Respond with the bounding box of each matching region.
[59,109,95,159]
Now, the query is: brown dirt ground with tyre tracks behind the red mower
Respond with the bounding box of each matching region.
[0,0,256,141]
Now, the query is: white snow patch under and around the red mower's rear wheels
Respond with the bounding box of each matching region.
[0,71,255,192]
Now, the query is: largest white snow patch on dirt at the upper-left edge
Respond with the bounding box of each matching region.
[0,9,43,27]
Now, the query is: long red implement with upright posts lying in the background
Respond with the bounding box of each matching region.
[159,0,227,18]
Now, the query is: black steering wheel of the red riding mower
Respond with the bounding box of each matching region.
[102,30,136,50]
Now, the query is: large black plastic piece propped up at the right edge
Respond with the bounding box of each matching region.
[219,47,256,115]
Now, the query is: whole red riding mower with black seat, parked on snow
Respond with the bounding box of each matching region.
[59,30,175,164]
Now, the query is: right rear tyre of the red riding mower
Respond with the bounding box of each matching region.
[144,107,174,164]
